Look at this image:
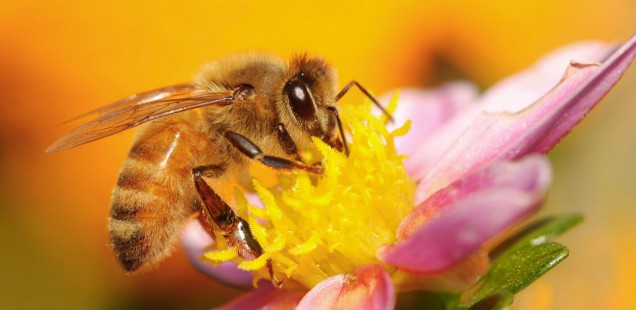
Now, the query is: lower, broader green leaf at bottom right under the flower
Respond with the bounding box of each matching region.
[462,242,568,307]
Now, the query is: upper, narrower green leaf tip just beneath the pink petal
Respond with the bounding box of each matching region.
[490,214,583,260]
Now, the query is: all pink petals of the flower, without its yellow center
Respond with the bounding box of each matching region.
[184,37,636,309]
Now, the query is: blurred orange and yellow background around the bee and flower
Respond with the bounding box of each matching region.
[0,0,636,309]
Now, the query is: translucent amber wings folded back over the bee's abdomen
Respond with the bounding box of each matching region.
[46,84,234,153]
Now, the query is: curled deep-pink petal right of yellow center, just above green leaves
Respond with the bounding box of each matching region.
[378,155,551,273]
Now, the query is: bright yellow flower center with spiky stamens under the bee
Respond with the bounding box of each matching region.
[206,96,415,289]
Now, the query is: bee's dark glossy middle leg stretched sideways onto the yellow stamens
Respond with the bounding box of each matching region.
[225,131,323,174]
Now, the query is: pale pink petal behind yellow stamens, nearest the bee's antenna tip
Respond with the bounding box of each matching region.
[383,82,478,174]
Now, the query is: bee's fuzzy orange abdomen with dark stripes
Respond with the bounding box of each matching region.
[108,117,214,272]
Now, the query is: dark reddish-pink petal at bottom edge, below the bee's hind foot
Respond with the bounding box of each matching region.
[217,285,305,310]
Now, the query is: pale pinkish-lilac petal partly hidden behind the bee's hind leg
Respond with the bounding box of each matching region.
[181,219,252,288]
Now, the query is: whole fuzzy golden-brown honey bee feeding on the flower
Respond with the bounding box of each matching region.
[46,54,388,281]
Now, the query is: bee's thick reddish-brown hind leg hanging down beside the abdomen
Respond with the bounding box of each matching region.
[192,165,282,287]
